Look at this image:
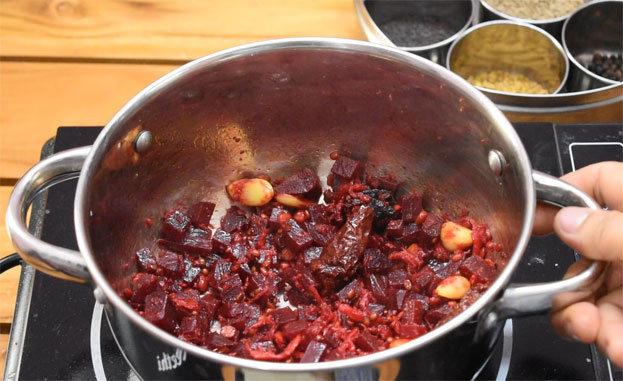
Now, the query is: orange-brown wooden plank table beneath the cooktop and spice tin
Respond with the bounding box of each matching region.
[0,0,623,374]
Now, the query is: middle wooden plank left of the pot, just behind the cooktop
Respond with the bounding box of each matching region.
[0,62,177,180]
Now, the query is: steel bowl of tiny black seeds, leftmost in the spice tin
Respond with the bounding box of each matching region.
[355,0,479,65]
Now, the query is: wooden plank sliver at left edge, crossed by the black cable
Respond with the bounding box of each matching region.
[0,186,21,324]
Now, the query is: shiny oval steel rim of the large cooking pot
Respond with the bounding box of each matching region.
[74,37,536,372]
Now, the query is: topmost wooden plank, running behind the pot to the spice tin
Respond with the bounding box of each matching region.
[0,0,364,60]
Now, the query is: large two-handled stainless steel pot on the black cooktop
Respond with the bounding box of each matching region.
[7,38,604,379]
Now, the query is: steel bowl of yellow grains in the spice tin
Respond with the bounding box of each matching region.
[446,21,568,98]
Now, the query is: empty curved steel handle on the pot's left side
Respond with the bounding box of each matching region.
[6,146,91,282]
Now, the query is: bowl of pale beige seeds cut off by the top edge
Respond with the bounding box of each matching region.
[480,0,586,39]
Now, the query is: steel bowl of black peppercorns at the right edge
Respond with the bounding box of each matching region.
[562,0,623,91]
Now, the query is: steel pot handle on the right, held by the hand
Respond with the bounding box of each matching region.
[485,171,607,323]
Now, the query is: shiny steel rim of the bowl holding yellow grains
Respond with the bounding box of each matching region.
[446,20,575,97]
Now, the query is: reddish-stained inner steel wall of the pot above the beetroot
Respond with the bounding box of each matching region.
[79,43,533,330]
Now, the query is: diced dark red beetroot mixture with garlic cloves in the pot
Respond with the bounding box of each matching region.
[123,153,506,362]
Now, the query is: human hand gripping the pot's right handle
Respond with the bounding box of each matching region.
[533,162,623,367]
